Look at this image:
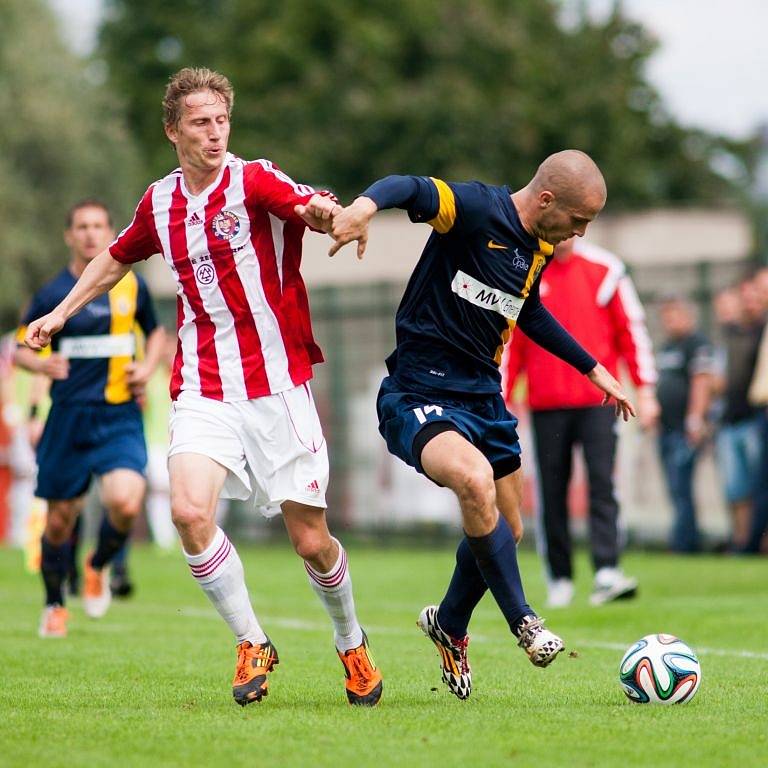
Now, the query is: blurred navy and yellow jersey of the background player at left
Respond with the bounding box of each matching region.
[17,268,157,404]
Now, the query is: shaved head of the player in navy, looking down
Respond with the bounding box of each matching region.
[512,149,607,245]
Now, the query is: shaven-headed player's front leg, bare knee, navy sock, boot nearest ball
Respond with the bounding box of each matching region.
[421,431,564,667]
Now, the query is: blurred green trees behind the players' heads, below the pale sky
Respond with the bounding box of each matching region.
[0,0,765,327]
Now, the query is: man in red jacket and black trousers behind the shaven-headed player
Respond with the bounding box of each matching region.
[505,238,659,607]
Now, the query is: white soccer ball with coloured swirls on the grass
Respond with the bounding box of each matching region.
[619,635,701,704]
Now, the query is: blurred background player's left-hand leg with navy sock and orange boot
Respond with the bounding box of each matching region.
[38,497,84,637]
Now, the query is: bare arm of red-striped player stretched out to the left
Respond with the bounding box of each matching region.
[24,249,130,351]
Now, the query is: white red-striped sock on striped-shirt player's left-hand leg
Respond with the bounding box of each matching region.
[184,528,267,645]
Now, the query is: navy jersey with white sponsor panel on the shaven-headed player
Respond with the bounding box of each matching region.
[380,177,553,393]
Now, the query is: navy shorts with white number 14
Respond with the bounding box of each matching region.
[376,376,520,480]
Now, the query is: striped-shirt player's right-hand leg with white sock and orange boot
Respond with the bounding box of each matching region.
[282,501,382,707]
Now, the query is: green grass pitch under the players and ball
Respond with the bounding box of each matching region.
[0,547,768,768]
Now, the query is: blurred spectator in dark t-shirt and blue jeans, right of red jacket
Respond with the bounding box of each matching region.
[656,297,712,552]
